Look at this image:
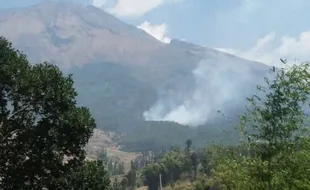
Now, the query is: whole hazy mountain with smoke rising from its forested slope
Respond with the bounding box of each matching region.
[0,1,269,149]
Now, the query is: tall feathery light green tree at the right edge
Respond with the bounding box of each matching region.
[246,63,310,189]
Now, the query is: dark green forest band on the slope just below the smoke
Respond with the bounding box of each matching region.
[119,121,239,152]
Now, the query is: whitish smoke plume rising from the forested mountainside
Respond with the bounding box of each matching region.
[143,54,268,127]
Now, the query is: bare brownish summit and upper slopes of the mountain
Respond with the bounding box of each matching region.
[0,1,162,67]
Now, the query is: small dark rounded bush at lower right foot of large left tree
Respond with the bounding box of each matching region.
[63,161,112,190]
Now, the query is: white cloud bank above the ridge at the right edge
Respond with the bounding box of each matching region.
[217,30,310,66]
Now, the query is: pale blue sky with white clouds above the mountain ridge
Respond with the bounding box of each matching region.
[0,0,310,63]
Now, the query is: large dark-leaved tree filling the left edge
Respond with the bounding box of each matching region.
[0,37,96,189]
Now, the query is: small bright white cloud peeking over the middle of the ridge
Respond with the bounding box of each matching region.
[137,21,171,43]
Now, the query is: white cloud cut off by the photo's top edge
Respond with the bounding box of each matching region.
[93,0,182,16]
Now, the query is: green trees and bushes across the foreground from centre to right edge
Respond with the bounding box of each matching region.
[117,63,310,190]
